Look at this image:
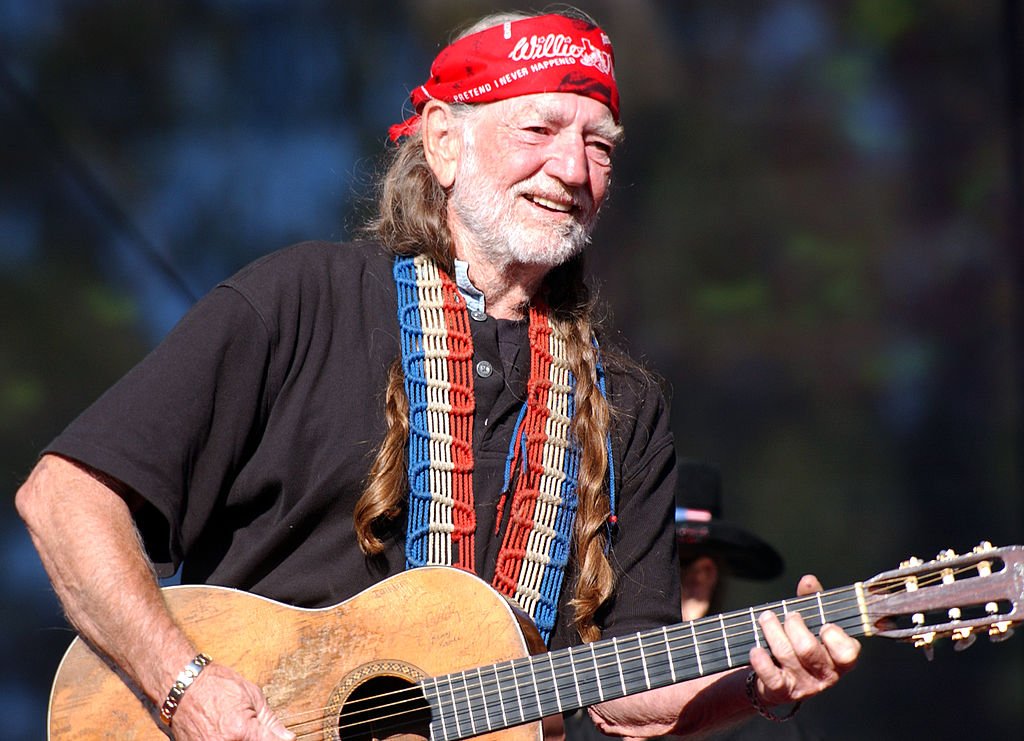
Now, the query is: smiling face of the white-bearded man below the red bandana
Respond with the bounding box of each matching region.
[450,93,622,268]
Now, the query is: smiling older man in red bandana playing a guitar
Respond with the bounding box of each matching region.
[17,7,858,739]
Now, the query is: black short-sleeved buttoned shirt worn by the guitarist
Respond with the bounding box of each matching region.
[47,243,679,647]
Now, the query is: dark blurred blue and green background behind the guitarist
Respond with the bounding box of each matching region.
[0,0,1024,739]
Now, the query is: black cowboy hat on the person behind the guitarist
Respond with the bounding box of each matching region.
[676,460,784,579]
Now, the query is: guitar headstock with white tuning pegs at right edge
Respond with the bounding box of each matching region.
[862,542,1024,652]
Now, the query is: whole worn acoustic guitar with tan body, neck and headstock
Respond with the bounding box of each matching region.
[48,542,1024,741]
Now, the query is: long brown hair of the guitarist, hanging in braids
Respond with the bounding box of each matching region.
[354,13,614,641]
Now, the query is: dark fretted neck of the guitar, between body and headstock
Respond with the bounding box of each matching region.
[421,583,867,741]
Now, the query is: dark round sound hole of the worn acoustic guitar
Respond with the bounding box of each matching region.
[338,675,430,741]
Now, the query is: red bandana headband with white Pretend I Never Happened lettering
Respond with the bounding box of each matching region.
[388,14,618,141]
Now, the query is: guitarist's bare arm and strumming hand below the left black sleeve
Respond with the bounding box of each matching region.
[15,455,295,741]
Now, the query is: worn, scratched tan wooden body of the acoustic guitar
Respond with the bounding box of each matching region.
[49,568,543,741]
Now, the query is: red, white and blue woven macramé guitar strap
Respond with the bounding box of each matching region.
[394,256,614,642]
